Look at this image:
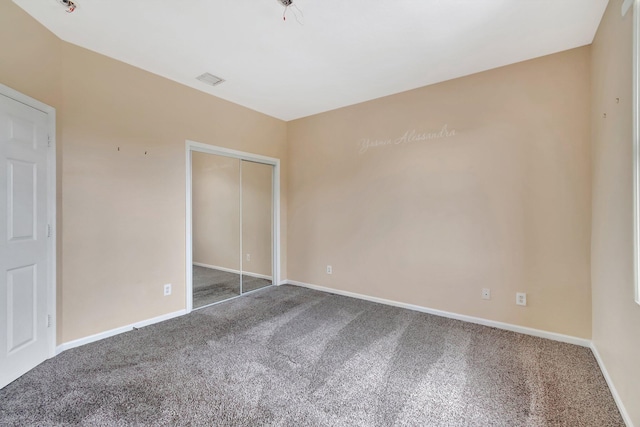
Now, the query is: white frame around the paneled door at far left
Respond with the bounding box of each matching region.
[0,83,58,358]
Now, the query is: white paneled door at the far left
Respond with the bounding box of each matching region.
[0,95,50,387]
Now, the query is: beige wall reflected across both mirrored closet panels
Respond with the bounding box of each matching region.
[192,152,272,276]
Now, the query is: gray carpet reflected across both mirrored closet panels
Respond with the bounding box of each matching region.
[193,265,271,308]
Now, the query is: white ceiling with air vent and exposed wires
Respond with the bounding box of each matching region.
[14,0,607,120]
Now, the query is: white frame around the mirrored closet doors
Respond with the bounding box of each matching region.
[185,140,280,313]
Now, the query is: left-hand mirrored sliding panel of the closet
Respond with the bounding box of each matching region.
[191,151,241,308]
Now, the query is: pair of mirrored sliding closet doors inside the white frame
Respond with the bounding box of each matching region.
[191,151,274,309]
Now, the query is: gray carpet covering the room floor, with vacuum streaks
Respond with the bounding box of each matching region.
[0,286,624,427]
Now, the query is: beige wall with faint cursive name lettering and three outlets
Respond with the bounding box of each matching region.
[288,47,591,338]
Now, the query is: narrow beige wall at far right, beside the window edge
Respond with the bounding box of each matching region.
[591,0,640,426]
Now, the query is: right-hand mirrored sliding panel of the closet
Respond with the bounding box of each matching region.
[241,160,273,293]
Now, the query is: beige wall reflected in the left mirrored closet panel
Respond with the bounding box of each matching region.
[191,152,240,270]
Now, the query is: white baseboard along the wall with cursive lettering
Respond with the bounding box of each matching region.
[287,280,591,347]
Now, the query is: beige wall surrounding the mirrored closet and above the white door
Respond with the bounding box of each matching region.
[0,1,286,344]
